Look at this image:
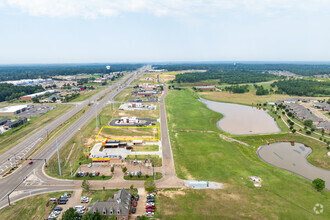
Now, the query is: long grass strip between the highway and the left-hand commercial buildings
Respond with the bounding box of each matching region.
[0,105,73,154]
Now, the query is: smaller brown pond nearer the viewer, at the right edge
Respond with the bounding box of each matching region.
[257,142,330,190]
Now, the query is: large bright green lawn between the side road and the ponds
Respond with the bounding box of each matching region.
[161,90,330,219]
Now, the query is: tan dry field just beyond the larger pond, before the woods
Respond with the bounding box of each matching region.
[198,89,324,105]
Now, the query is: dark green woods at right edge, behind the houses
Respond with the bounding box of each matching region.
[273,79,330,96]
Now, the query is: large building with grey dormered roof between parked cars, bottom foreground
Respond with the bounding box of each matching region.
[88,189,132,220]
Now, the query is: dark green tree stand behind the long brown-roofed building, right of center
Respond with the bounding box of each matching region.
[174,70,278,84]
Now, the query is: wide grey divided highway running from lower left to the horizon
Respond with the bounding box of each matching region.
[0,66,150,208]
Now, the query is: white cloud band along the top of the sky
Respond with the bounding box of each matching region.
[0,0,330,18]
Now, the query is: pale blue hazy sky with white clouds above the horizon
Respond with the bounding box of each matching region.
[0,0,330,64]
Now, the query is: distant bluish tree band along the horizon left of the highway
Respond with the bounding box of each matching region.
[0,64,143,81]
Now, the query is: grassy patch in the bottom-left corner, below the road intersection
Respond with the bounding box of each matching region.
[0,192,63,220]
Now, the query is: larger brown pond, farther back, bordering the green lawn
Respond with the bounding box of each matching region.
[200,98,281,135]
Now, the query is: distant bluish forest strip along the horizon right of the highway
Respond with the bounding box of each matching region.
[153,63,330,76]
